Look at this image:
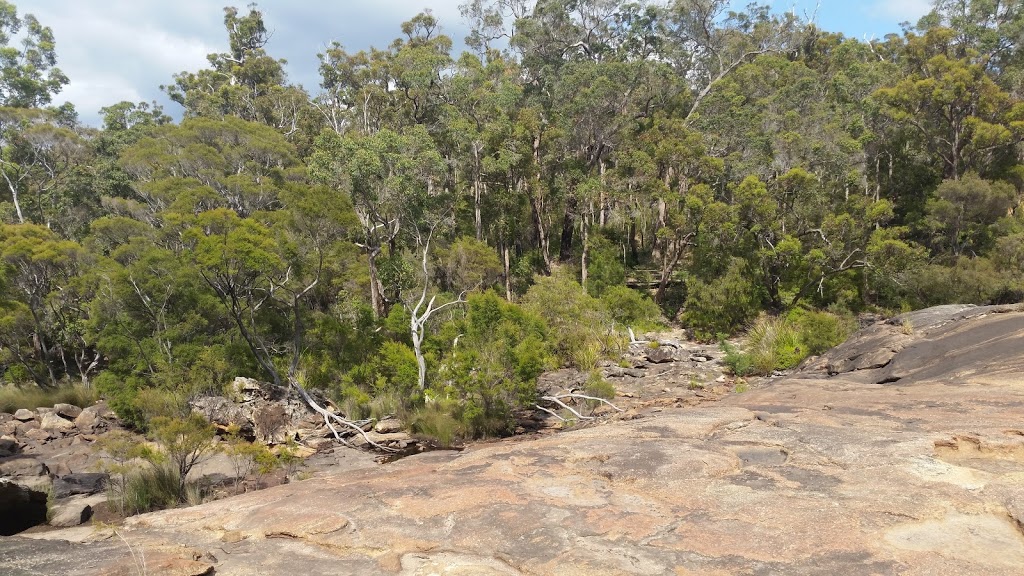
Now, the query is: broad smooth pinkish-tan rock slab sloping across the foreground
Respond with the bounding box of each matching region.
[8,308,1024,576]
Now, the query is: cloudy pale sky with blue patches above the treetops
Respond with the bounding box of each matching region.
[13,0,931,125]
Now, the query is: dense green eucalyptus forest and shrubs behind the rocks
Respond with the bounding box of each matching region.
[0,0,1024,436]
